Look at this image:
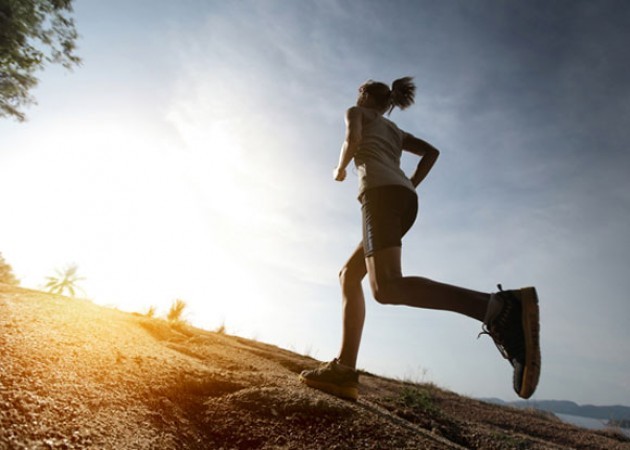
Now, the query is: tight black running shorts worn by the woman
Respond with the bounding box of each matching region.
[361,186,418,256]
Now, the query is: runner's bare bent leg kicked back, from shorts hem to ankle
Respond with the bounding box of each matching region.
[365,247,490,321]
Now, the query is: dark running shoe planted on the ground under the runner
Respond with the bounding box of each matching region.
[300,359,359,401]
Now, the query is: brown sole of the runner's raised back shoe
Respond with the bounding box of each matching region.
[518,287,540,399]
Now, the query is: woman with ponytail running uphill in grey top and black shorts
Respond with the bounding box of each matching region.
[300,77,540,400]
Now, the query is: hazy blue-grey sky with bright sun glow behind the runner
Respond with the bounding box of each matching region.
[0,0,630,405]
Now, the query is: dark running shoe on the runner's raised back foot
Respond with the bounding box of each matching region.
[480,285,540,398]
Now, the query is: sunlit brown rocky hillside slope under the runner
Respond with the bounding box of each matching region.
[0,284,630,449]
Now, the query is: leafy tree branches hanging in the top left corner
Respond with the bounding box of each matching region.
[0,0,81,121]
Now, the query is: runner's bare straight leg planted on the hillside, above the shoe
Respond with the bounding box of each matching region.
[338,244,367,368]
